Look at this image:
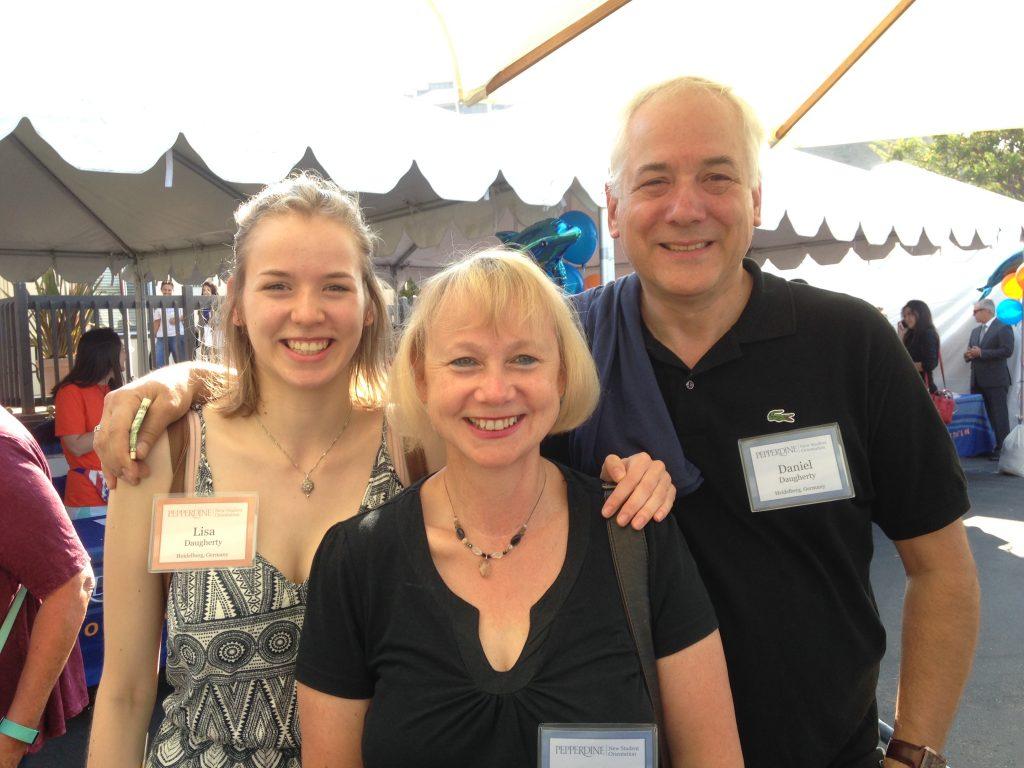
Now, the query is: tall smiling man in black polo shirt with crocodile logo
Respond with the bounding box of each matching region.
[561,79,979,768]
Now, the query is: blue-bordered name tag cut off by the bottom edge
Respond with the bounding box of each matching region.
[537,723,657,768]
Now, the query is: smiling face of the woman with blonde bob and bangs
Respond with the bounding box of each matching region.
[418,306,564,467]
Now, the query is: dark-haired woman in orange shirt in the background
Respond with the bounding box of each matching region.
[53,328,124,507]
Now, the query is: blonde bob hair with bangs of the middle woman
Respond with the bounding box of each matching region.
[390,248,600,442]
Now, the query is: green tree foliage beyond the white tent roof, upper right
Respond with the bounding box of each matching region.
[871,128,1024,200]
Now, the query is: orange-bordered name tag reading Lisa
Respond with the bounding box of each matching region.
[150,493,258,573]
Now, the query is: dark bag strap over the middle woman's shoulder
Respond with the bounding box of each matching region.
[608,517,671,768]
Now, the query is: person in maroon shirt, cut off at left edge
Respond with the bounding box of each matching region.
[0,409,93,768]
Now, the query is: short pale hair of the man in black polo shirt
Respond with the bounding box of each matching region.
[608,77,765,197]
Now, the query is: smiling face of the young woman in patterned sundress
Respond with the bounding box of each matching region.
[228,214,375,396]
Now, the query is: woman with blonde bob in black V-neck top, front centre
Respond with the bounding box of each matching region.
[296,251,742,768]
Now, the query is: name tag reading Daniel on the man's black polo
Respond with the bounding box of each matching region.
[739,424,854,512]
